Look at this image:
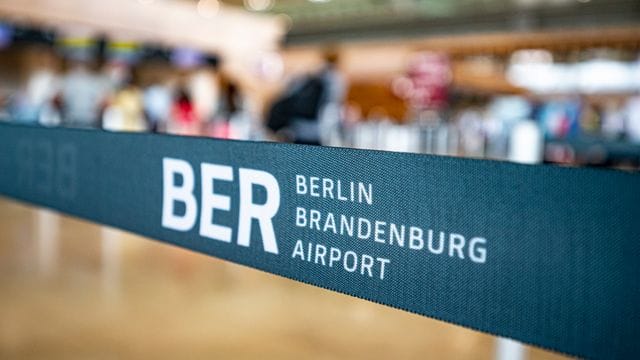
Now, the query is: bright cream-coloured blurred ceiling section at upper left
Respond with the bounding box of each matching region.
[0,0,285,58]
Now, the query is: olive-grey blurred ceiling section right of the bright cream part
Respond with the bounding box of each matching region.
[223,0,640,45]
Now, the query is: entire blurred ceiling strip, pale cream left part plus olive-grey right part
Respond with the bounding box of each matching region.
[0,0,640,49]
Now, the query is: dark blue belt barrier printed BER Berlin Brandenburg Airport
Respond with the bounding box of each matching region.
[0,124,640,358]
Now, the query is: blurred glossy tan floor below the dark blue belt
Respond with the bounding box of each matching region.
[0,198,562,359]
